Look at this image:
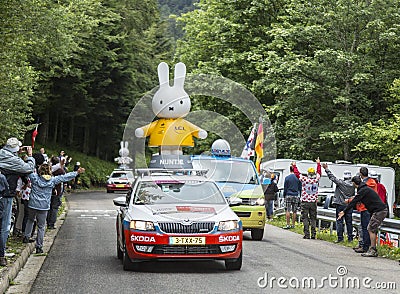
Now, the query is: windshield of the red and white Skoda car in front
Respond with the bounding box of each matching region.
[133,180,226,205]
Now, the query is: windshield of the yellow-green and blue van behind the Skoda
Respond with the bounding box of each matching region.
[192,158,258,184]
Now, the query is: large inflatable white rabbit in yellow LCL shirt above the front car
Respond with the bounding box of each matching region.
[135,62,207,155]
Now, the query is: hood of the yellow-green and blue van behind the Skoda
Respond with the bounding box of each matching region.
[217,182,264,198]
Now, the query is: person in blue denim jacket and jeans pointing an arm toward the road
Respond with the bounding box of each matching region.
[23,163,85,253]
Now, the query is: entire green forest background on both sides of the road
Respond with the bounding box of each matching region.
[0,0,400,187]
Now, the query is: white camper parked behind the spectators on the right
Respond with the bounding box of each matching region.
[261,159,396,218]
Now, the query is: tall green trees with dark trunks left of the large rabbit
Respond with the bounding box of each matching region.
[0,0,172,160]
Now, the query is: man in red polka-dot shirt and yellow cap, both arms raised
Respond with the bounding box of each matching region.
[292,158,321,239]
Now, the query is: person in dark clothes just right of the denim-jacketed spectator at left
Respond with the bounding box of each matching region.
[46,156,66,230]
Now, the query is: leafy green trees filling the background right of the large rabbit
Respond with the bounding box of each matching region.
[176,0,400,167]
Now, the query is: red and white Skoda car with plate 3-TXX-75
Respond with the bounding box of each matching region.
[114,173,243,270]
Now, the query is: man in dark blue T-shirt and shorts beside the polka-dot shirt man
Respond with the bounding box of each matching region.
[283,165,301,229]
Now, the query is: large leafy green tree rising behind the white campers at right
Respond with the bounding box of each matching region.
[264,0,399,160]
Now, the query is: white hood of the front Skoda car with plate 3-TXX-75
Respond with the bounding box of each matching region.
[128,204,239,222]
